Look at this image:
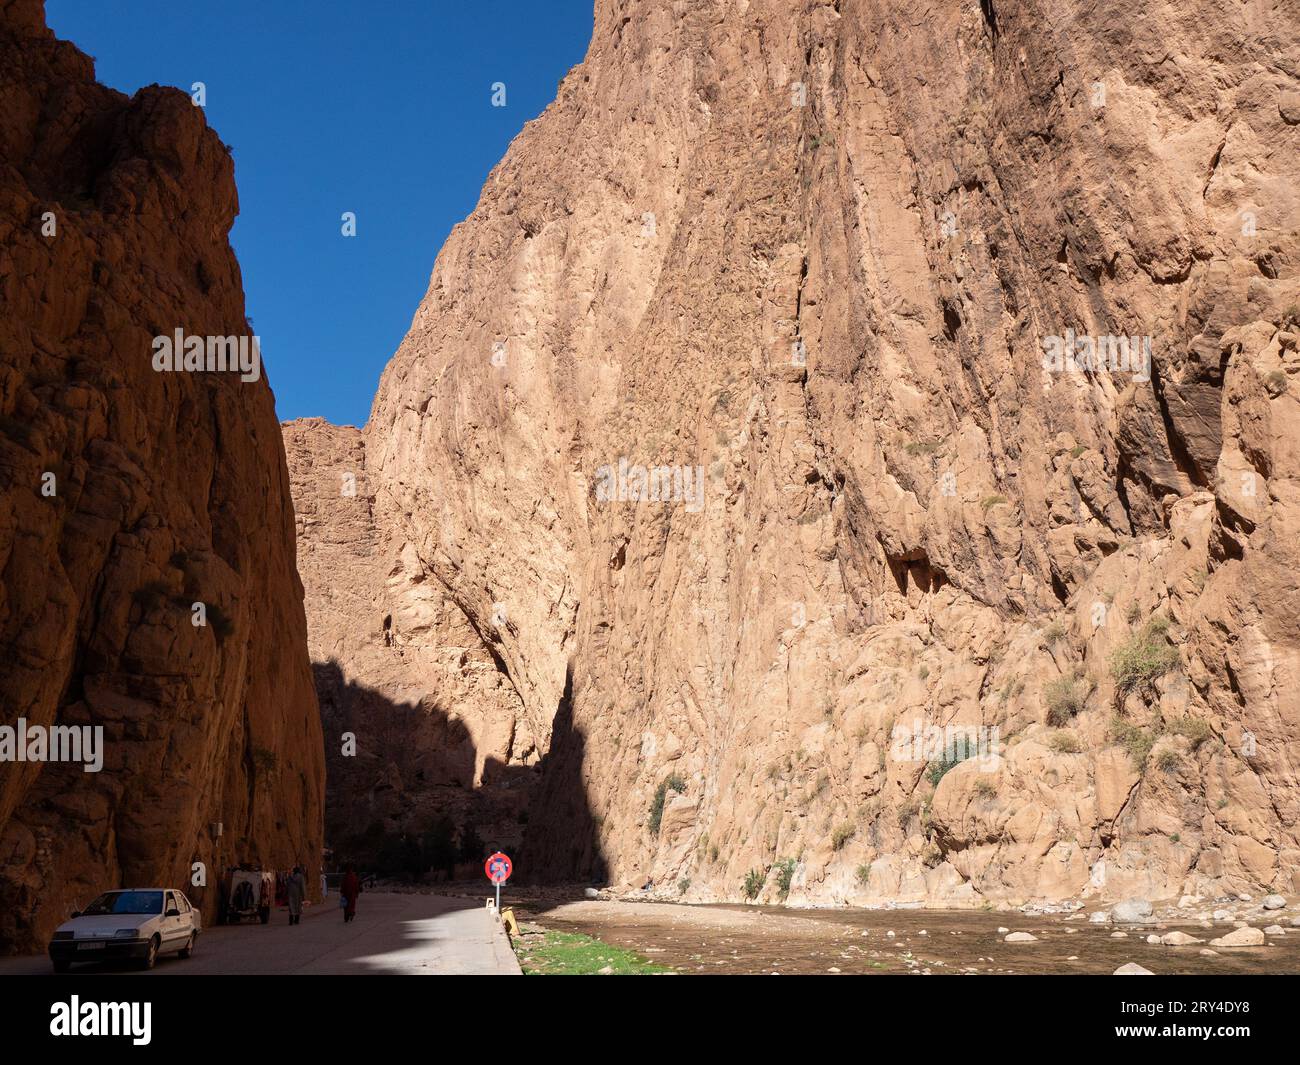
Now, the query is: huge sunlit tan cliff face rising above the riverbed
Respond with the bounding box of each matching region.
[345,0,1300,905]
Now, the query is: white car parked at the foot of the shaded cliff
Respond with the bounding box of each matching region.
[49,888,202,973]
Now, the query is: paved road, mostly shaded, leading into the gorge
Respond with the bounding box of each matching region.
[0,892,519,977]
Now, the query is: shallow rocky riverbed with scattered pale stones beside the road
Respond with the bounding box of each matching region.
[515,896,1300,975]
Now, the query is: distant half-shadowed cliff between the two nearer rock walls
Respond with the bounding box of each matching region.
[282,419,538,873]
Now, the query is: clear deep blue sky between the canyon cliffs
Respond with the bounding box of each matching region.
[47,0,593,425]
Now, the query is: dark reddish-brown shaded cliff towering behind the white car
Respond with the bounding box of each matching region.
[0,0,324,949]
